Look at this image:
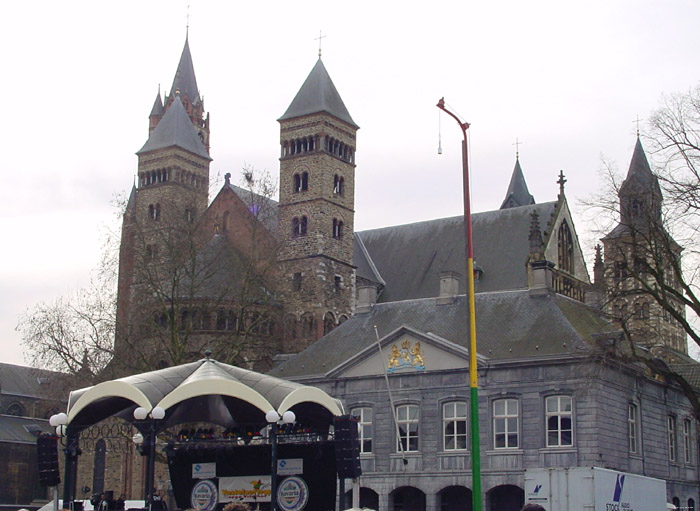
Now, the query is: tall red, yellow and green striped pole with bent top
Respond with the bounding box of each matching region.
[436,98,482,511]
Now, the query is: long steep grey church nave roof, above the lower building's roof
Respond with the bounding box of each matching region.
[353,202,557,302]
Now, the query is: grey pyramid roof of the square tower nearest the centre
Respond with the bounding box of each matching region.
[278,58,358,128]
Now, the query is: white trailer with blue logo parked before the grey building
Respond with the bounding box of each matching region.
[525,467,666,511]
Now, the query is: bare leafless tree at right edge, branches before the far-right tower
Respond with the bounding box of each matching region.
[586,88,700,418]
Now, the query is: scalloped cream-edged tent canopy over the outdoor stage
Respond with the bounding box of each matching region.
[67,358,343,430]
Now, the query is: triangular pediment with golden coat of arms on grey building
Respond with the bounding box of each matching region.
[328,326,469,378]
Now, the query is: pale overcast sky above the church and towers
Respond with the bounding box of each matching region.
[0,0,700,364]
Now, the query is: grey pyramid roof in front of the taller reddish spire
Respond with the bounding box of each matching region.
[136,96,211,160]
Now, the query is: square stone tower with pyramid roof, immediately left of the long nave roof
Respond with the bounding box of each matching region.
[278,57,358,352]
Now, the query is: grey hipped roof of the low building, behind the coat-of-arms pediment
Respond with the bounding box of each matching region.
[269,291,615,378]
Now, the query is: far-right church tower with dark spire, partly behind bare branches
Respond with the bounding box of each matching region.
[596,138,687,353]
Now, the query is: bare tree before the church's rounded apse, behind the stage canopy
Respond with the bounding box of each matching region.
[113,169,279,372]
